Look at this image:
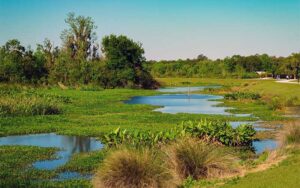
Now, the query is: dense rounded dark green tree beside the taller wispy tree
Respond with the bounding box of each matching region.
[102,35,155,88]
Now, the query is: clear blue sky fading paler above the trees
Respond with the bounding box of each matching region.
[0,0,300,60]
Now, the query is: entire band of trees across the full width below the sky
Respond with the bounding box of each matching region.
[0,13,300,88]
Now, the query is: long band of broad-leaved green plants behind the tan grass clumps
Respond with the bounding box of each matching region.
[101,120,255,147]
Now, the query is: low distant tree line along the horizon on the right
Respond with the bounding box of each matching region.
[147,53,300,78]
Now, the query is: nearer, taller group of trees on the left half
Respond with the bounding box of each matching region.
[0,13,157,88]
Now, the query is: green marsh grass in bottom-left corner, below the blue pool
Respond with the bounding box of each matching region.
[0,146,57,187]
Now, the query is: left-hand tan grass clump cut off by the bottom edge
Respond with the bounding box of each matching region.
[93,149,176,188]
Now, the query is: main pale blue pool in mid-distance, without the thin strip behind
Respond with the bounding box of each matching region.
[126,94,230,115]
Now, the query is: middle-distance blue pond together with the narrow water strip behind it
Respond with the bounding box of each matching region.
[125,86,251,116]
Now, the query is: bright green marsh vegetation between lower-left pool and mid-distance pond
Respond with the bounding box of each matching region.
[0,88,253,136]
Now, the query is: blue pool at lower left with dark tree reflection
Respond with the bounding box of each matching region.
[0,133,103,170]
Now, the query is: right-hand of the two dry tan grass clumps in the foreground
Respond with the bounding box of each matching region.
[164,138,237,179]
